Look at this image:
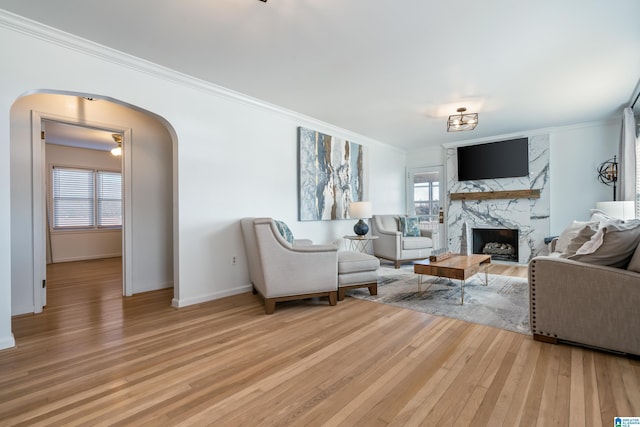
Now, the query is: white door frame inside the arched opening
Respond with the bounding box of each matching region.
[31,110,133,313]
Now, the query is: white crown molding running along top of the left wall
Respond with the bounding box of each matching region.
[0,9,392,152]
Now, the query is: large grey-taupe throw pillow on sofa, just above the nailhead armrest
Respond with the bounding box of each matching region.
[568,219,640,268]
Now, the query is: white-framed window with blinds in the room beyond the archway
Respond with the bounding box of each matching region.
[51,166,122,230]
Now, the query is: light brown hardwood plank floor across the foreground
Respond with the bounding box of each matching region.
[0,259,640,426]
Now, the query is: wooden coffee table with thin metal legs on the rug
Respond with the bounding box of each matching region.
[413,255,491,305]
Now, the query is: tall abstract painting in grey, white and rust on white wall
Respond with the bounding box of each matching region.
[298,127,364,221]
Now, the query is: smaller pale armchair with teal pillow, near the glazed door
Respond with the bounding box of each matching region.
[371,215,434,268]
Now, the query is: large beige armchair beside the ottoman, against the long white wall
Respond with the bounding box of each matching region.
[240,218,338,314]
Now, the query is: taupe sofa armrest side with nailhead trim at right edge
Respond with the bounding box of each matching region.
[529,256,640,354]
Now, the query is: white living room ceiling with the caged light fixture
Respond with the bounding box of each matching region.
[0,0,640,150]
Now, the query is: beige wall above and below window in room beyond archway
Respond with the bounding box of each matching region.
[41,145,124,262]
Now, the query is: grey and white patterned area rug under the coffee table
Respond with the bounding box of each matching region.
[347,265,531,334]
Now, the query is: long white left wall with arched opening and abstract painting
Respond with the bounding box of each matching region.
[0,15,405,348]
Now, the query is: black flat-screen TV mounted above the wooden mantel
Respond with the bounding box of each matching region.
[458,138,529,181]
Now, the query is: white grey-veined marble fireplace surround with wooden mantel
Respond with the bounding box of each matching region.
[446,134,550,264]
